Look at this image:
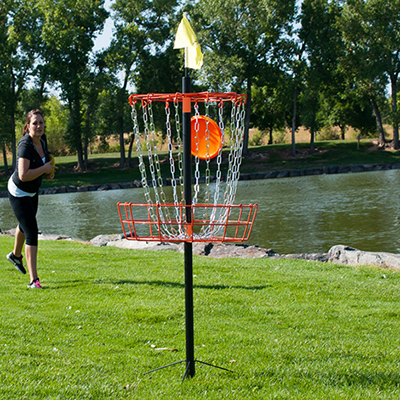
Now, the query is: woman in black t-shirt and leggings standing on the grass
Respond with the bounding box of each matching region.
[7,110,56,289]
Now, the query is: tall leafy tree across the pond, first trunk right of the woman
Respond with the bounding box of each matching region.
[38,0,108,170]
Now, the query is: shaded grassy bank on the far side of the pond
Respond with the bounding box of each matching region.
[0,140,400,191]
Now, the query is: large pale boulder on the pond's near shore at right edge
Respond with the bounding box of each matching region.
[328,245,400,270]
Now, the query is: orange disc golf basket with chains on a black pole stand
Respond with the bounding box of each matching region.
[118,88,257,379]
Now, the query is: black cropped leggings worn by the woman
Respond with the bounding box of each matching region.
[8,193,39,246]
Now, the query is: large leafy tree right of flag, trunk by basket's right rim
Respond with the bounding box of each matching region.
[193,0,295,154]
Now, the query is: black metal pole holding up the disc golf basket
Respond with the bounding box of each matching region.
[182,69,195,377]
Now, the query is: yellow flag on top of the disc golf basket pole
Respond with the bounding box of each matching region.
[174,15,203,69]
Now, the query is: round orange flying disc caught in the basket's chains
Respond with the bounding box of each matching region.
[191,115,222,160]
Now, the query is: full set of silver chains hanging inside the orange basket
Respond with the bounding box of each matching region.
[131,96,245,240]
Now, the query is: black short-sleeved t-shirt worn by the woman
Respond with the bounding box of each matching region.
[12,134,50,193]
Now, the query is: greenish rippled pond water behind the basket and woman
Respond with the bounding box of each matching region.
[0,170,400,254]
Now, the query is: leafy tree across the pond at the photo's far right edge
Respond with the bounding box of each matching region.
[342,0,400,149]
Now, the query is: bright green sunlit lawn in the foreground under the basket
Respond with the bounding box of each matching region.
[0,237,400,400]
